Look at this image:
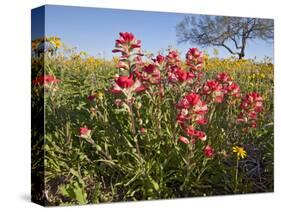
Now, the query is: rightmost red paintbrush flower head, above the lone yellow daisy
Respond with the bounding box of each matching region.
[237,92,263,128]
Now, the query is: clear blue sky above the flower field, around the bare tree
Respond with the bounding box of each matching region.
[32,5,273,59]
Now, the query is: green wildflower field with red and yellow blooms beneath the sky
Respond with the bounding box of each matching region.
[32,32,274,205]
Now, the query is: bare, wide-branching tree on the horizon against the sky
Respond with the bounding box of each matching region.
[176,15,274,59]
